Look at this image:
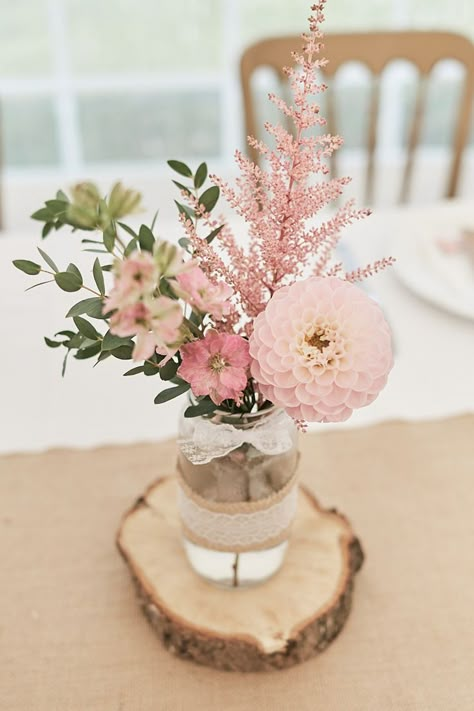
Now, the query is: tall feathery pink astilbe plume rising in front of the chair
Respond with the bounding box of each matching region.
[178,0,391,333]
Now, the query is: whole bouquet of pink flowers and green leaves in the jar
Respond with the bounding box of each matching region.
[15,1,393,422]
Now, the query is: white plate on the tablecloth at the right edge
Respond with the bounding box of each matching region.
[395,226,474,320]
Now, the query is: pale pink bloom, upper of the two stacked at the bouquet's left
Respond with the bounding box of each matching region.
[104,251,159,313]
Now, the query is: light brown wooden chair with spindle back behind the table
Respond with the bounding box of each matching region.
[240,32,474,202]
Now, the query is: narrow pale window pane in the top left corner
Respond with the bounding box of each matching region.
[0,0,51,77]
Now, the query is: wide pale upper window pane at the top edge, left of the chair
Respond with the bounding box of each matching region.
[67,0,222,73]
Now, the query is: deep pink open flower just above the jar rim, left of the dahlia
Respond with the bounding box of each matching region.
[178,330,250,405]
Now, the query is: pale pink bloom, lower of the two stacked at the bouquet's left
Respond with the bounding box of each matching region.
[110,296,183,360]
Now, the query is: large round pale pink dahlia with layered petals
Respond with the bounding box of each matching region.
[250,276,393,422]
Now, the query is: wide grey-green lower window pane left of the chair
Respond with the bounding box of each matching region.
[79,91,220,162]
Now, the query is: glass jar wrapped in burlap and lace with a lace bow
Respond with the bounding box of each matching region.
[178,406,299,587]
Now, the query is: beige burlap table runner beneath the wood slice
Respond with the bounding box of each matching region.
[0,416,474,711]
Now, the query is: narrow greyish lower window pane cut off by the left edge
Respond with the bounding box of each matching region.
[2,96,59,167]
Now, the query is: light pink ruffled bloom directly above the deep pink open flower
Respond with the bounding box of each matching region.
[175,267,233,319]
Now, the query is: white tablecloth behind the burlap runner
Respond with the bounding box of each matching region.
[0,201,474,452]
